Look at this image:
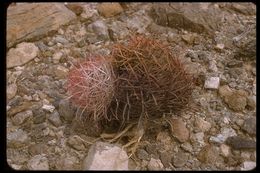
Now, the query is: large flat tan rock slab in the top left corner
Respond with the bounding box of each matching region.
[6,3,76,47]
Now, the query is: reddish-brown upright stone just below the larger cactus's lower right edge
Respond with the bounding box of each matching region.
[171,118,190,142]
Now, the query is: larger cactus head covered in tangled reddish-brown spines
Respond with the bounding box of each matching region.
[106,36,193,123]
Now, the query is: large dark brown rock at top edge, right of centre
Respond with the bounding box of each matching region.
[149,3,221,35]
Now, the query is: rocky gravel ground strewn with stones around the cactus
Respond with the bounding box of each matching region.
[6,3,256,170]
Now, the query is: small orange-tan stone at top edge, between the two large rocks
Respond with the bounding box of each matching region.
[97,2,123,17]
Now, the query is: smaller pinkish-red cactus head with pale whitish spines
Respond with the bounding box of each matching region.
[67,56,114,121]
